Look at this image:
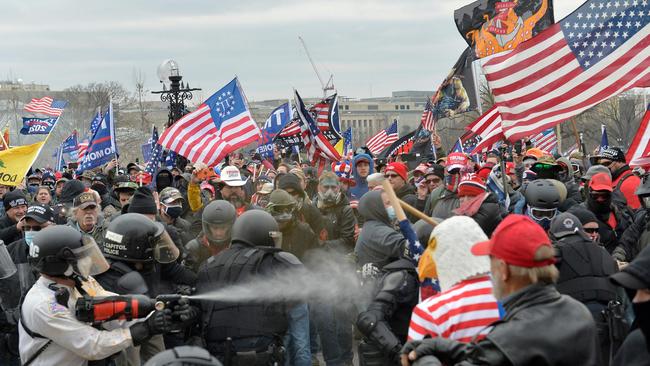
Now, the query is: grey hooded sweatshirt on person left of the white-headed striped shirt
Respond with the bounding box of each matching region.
[354,191,406,268]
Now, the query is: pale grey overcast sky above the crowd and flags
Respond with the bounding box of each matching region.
[0,0,583,100]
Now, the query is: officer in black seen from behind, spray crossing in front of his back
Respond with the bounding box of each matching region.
[197,210,302,365]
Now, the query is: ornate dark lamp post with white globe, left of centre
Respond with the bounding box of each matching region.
[151,60,201,170]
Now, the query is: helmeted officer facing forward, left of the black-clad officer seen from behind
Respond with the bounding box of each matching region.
[183,200,237,272]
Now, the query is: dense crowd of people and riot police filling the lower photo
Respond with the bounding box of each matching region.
[0,147,650,366]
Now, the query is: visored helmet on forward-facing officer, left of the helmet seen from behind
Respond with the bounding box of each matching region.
[201,200,237,246]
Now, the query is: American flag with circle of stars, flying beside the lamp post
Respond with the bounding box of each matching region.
[160,78,261,166]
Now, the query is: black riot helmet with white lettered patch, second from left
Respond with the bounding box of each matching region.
[102,213,179,263]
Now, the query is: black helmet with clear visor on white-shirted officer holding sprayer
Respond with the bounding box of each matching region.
[29,226,109,280]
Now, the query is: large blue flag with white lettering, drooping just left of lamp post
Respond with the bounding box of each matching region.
[77,104,118,172]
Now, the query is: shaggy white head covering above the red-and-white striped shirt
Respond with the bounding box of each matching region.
[431,216,490,291]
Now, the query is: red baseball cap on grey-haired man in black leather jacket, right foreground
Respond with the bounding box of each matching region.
[472,214,555,268]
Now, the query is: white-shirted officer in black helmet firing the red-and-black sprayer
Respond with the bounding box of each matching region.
[19,226,177,366]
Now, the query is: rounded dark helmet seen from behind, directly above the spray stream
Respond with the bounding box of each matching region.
[232,210,282,248]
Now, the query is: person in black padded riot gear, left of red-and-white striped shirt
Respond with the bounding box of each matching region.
[356,258,418,366]
